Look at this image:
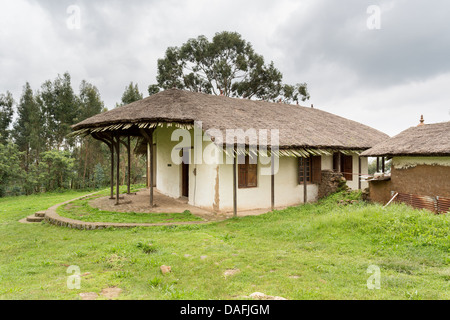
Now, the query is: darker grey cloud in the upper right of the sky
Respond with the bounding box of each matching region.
[277,0,450,86]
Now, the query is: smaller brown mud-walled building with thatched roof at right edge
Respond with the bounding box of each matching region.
[361,116,450,213]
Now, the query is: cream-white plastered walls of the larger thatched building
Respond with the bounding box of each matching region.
[155,127,368,212]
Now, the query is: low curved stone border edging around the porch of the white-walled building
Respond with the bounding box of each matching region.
[45,192,208,230]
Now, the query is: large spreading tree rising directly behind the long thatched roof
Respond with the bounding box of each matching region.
[149,32,309,102]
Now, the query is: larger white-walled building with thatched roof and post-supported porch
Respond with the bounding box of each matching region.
[73,89,389,213]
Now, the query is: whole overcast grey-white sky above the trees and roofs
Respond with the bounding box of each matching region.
[0,0,450,136]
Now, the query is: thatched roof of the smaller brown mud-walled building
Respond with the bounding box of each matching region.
[361,121,450,157]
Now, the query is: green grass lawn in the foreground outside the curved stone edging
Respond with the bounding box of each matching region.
[0,191,450,300]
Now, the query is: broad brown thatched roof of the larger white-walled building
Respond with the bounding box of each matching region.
[73,89,389,154]
